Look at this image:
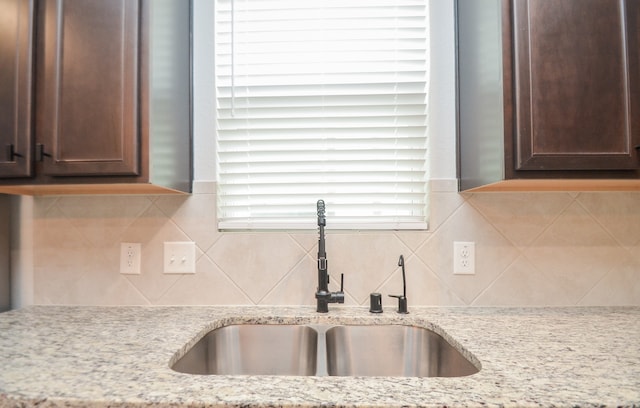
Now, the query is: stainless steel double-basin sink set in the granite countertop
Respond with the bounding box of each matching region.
[171,324,479,377]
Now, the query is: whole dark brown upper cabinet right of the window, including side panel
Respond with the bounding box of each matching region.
[457,0,640,190]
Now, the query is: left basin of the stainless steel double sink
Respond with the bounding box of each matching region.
[171,324,318,375]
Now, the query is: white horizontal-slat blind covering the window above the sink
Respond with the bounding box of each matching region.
[215,0,429,229]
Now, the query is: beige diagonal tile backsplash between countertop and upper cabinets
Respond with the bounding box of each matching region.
[33,188,640,310]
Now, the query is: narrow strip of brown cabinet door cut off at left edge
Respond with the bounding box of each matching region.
[0,0,34,178]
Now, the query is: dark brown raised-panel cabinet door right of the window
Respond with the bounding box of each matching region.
[512,0,640,170]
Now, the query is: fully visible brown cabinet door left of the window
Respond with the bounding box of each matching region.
[36,0,139,176]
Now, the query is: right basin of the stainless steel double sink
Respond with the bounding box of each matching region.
[326,325,478,377]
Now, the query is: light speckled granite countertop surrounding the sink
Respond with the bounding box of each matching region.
[0,305,640,408]
